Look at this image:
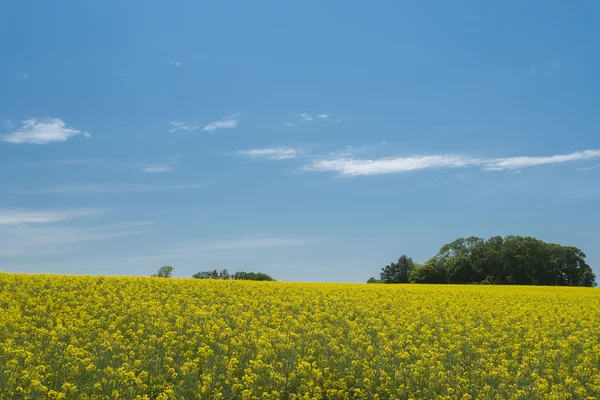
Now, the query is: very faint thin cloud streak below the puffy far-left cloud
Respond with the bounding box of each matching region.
[11,182,211,194]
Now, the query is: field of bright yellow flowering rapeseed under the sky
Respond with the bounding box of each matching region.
[0,274,600,399]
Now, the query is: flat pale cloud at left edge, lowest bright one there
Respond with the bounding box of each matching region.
[0,209,106,225]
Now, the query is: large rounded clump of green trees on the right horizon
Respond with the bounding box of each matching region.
[367,236,596,286]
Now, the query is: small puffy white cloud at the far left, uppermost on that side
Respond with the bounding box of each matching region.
[0,118,91,144]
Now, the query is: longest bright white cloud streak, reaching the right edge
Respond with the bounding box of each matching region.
[301,150,600,177]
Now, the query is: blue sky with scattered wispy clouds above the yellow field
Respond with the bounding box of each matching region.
[0,0,600,282]
